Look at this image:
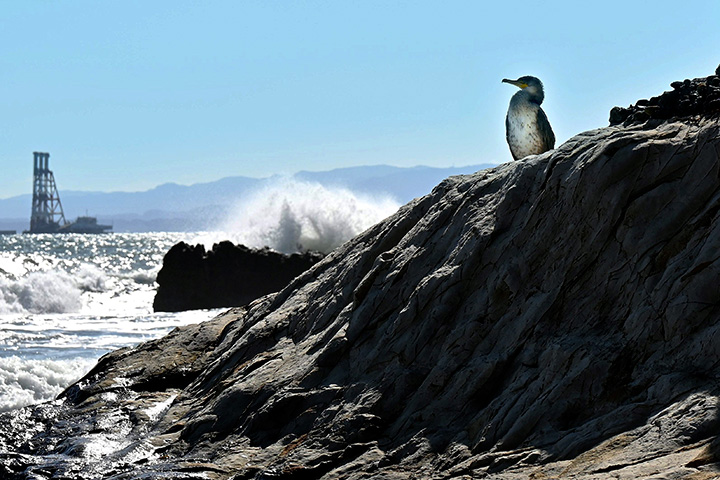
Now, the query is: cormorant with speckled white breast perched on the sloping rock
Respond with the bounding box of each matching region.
[503,75,555,160]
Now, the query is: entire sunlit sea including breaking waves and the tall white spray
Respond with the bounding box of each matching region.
[0,181,399,412]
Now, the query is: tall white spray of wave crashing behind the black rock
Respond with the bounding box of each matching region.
[214,179,400,253]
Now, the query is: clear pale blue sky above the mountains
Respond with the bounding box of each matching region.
[0,0,720,198]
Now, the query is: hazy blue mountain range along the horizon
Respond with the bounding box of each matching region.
[0,164,494,232]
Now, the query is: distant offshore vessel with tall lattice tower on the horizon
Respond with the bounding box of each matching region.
[24,152,112,233]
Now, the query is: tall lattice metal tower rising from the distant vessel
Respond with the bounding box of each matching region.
[30,152,67,233]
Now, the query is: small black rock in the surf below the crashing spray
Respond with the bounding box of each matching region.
[153,242,323,312]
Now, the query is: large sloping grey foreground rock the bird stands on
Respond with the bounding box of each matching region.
[0,72,720,480]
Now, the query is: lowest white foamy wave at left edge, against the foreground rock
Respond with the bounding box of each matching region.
[0,356,96,412]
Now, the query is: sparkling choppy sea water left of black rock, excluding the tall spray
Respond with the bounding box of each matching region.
[0,233,217,411]
